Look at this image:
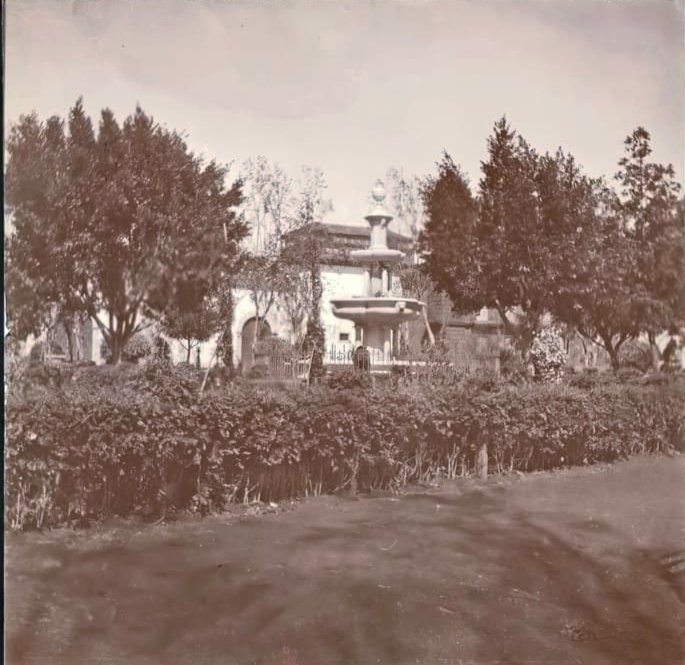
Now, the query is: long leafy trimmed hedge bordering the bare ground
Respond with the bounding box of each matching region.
[5,368,685,529]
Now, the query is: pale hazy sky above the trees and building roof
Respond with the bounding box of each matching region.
[5,0,685,223]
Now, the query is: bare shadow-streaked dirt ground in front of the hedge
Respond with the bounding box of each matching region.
[5,457,685,665]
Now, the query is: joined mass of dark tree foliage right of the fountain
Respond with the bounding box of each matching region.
[420,118,685,369]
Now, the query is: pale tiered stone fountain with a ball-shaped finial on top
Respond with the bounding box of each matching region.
[331,180,425,371]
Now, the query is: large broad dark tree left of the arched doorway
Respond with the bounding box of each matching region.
[6,100,246,362]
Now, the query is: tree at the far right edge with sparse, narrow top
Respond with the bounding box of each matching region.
[553,128,683,370]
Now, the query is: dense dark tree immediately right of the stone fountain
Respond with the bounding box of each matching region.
[420,118,612,358]
